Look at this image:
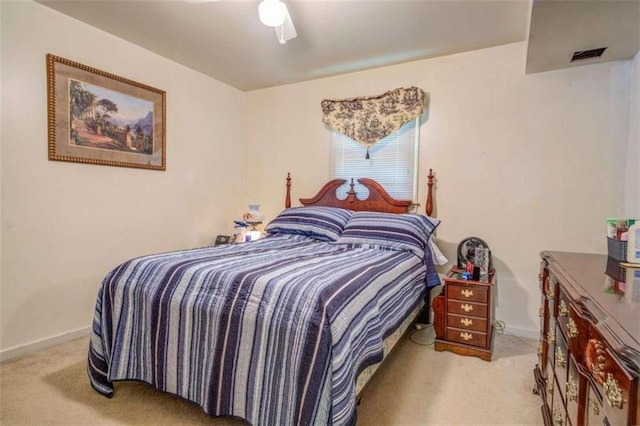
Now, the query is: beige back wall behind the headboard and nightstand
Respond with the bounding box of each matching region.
[246,43,631,335]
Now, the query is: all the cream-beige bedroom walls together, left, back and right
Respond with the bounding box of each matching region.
[0,2,640,358]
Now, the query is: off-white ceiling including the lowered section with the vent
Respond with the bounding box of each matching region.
[37,0,640,91]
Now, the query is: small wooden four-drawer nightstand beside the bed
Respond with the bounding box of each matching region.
[433,267,496,361]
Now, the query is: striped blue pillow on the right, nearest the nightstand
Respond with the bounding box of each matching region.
[337,212,440,257]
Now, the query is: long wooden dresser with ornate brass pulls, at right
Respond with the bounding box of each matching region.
[534,251,640,426]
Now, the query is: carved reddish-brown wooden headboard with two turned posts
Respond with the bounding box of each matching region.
[284,169,434,216]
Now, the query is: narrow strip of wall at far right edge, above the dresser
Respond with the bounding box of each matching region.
[624,52,640,219]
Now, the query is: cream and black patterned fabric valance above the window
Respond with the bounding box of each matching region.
[321,87,424,148]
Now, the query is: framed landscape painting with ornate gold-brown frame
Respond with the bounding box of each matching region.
[47,54,167,170]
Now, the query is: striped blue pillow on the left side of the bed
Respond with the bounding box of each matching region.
[264,207,353,241]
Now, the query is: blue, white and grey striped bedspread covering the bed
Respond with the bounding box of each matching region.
[87,235,438,425]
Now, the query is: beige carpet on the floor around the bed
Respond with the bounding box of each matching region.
[0,328,542,426]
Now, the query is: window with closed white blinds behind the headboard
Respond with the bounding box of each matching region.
[332,118,420,202]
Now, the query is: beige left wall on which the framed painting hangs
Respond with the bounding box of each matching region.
[0,2,245,357]
